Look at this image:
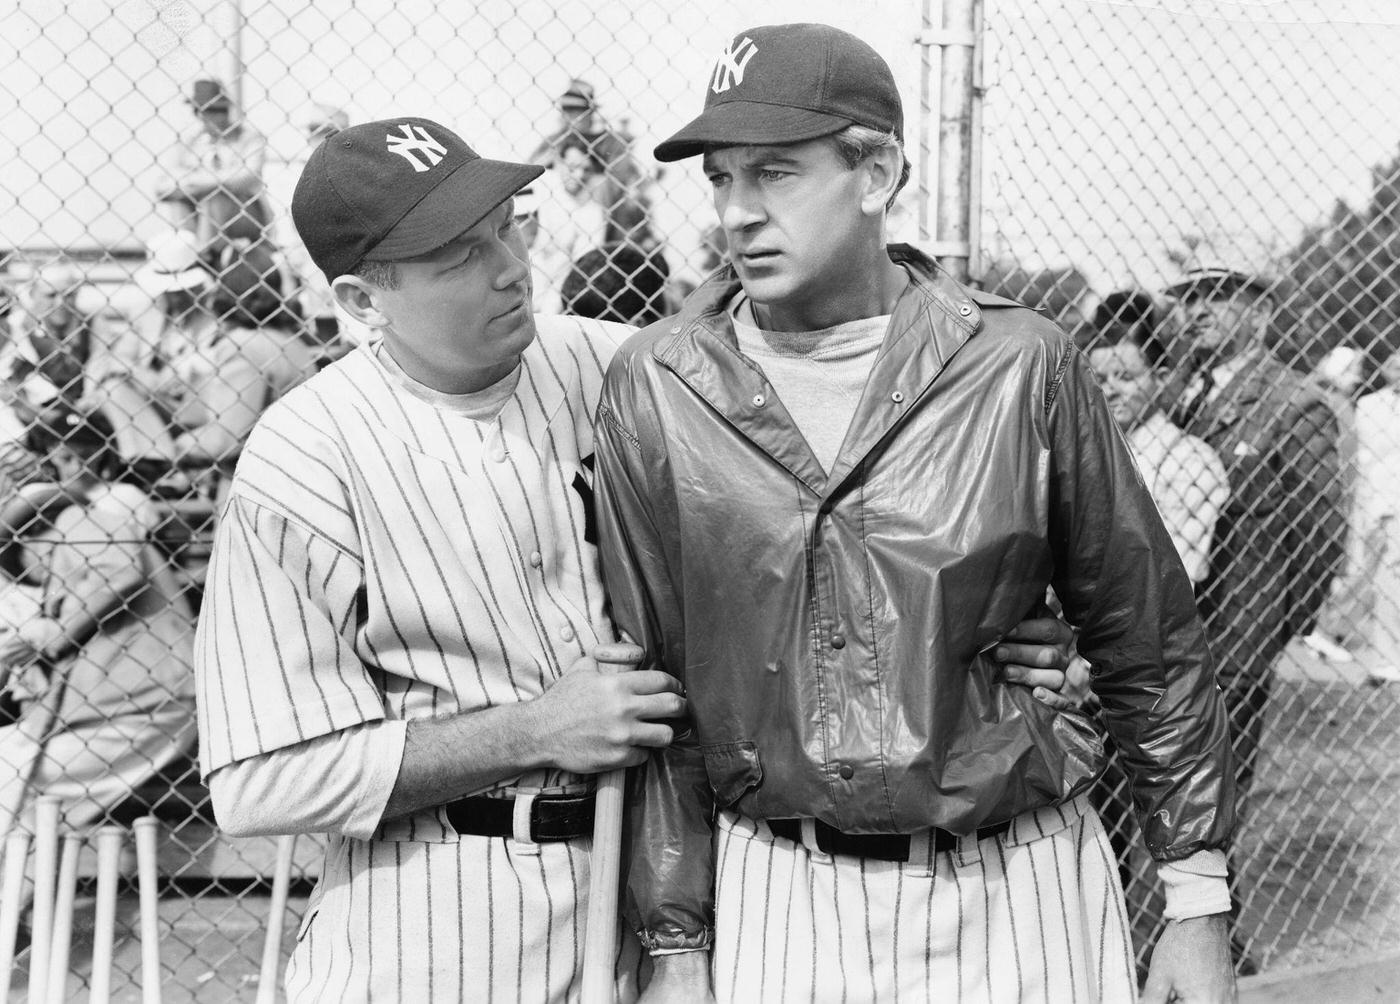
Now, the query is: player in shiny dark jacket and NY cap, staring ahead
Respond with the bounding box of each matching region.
[596,24,1233,1001]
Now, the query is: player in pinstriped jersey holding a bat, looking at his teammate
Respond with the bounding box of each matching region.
[196,118,1064,1001]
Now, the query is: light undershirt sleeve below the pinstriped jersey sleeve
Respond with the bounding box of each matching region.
[209,721,409,840]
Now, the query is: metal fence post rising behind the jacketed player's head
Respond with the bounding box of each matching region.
[920,0,980,281]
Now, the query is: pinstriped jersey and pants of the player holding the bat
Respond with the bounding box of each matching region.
[196,310,631,1001]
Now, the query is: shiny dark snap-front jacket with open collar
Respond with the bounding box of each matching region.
[596,245,1233,949]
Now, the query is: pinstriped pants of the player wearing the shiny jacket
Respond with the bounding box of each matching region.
[714,795,1137,1004]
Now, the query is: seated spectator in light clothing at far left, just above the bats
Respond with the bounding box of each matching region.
[0,405,195,851]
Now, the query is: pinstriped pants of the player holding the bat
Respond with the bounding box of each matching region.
[286,836,641,1004]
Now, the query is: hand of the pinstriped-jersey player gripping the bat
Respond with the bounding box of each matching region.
[531,650,686,774]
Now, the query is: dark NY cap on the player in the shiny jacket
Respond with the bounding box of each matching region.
[655,24,904,161]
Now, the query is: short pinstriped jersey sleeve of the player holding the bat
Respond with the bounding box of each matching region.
[195,482,388,776]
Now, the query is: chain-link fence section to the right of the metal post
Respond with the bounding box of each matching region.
[974,0,1400,970]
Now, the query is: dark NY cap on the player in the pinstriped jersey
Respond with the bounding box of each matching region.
[291,118,545,280]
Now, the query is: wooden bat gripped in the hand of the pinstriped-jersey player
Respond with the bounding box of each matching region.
[581,644,643,1004]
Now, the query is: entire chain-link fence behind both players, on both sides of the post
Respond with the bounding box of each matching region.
[0,0,1400,1000]
